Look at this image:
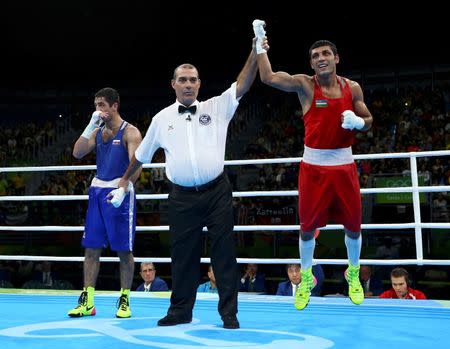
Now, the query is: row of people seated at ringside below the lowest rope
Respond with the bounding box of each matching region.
[0,259,436,299]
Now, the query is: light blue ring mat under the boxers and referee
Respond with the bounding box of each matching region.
[0,289,450,349]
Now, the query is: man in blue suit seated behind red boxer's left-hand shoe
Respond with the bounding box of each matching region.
[277,264,324,297]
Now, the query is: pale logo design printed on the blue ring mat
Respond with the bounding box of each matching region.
[0,317,335,349]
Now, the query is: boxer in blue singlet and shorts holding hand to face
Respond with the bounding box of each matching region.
[68,88,142,318]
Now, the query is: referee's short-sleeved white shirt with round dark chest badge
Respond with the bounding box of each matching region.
[135,82,239,187]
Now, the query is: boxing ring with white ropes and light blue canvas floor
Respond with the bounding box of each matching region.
[0,151,450,349]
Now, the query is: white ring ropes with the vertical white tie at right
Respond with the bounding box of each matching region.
[0,150,450,265]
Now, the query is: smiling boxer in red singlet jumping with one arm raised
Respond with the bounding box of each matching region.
[253,20,372,310]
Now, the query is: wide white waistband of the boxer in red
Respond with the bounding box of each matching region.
[302,145,354,166]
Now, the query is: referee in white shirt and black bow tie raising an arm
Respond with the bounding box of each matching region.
[111,40,257,329]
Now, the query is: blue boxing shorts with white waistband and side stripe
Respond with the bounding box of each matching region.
[81,178,136,252]
